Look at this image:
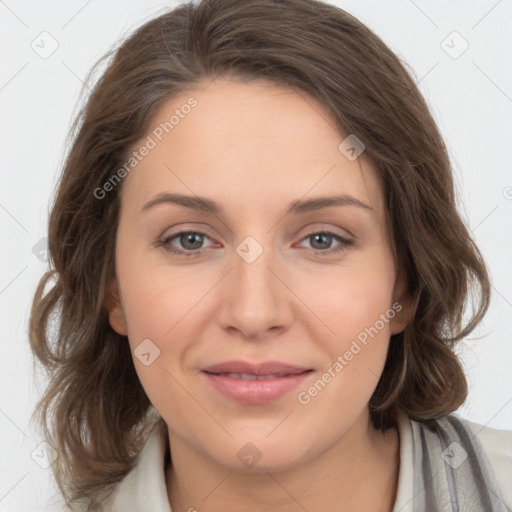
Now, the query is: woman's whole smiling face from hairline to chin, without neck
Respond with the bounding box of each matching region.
[109,79,408,470]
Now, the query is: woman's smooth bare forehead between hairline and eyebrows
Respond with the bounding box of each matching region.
[122,79,382,220]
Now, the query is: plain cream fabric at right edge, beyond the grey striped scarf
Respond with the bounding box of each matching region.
[465,420,512,510]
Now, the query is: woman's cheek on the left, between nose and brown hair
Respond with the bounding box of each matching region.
[117,248,218,400]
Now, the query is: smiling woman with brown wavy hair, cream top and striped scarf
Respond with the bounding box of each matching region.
[30,0,512,512]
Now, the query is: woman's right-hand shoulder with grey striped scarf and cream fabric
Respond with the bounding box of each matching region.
[404,412,512,512]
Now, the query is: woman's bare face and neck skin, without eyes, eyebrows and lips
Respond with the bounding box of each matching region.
[108,78,408,512]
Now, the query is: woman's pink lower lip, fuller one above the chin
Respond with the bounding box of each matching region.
[203,371,312,405]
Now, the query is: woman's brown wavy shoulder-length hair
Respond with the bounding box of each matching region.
[30,0,490,510]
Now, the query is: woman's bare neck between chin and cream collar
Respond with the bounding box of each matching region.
[166,409,400,512]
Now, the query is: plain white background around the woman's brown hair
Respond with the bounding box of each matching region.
[0,0,512,511]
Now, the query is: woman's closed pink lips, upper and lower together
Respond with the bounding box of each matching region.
[202,361,313,405]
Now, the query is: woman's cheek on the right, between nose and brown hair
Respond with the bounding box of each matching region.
[305,264,396,400]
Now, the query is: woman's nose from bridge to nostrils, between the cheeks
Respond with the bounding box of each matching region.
[219,241,294,341]
